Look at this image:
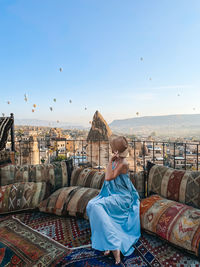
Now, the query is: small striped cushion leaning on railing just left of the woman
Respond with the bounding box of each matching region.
[70,168,105,189]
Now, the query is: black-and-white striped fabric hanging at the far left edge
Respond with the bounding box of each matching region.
[0,117,14,151]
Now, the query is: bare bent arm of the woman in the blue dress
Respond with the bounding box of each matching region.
[105,157,128,181]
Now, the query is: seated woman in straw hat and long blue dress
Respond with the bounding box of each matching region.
[87,136,140,264]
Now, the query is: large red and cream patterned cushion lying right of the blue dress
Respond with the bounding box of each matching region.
[140,195,200,256]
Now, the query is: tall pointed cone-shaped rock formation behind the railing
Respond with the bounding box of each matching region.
[86,111,112,167]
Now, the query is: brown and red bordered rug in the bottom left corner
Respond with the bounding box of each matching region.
[0,216,69,267]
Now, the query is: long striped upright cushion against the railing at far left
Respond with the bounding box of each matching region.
[0,161,68,192]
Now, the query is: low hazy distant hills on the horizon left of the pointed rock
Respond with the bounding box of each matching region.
[15,119,85,129]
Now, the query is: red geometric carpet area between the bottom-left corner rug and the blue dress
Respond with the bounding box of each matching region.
[14,211,91,248]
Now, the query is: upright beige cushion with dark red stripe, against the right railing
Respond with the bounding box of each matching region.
[148,165,200,208]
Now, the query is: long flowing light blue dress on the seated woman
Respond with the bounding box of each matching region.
[86,163,140,256]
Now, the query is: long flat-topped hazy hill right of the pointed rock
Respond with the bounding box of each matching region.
[109,114,200,136]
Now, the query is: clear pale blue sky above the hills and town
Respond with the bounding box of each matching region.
[0,0,200,126]
